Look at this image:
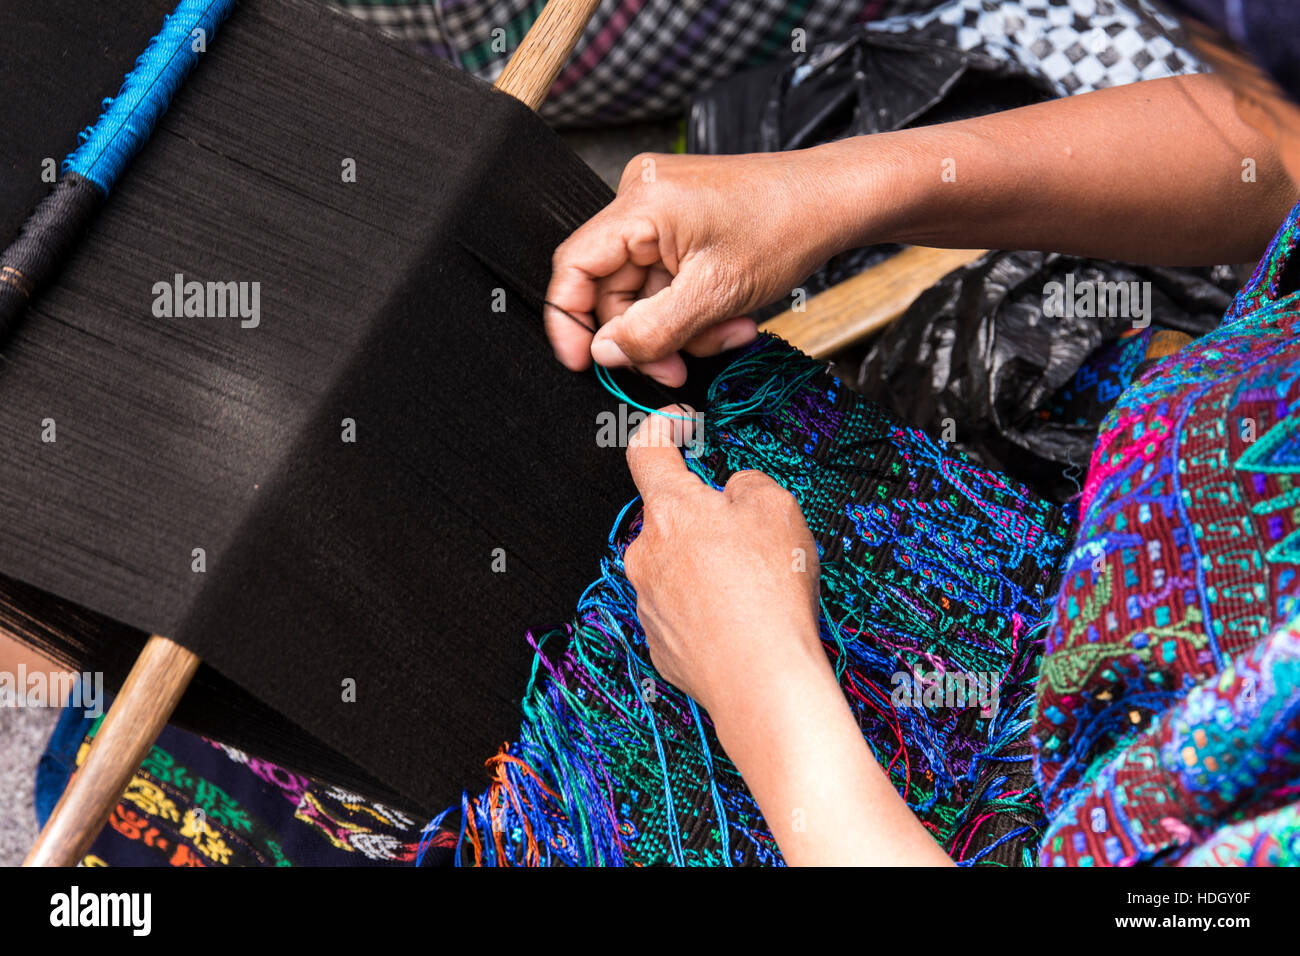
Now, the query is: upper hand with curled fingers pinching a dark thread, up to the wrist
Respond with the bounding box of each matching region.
[545,150,849,386]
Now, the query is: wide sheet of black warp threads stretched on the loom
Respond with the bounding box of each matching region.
[0,0,728,810]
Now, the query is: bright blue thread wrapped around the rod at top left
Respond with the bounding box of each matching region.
[64,0,235,194]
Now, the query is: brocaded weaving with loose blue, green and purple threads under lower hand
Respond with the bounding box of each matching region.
[425,338,1066,865]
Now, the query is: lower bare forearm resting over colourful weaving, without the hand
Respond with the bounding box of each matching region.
[711,639,952,866]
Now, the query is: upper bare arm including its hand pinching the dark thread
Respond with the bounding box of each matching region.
[546,75,1296,385]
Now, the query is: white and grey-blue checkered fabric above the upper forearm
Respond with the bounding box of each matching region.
[870,0,1204,96]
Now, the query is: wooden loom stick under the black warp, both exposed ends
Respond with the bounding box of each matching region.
[23,0,599,866]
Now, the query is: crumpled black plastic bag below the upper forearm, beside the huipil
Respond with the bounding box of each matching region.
[837,252,1236,502]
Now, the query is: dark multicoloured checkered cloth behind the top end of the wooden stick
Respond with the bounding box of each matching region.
[326,0,936,126]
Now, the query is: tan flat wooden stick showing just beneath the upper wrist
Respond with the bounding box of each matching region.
[763,246,984,359]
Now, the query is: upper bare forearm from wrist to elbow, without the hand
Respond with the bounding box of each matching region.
[805,75,1296,265]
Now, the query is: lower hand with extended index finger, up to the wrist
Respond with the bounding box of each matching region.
[624,407,829,717]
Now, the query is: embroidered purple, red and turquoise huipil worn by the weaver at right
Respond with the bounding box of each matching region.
[1034,207,1300,865]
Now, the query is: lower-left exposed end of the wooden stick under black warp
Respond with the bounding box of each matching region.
[22,636,199,866]
